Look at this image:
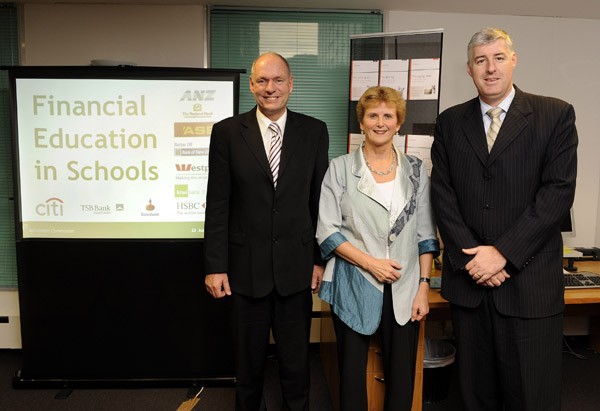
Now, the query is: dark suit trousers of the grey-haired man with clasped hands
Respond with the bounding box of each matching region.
[451,290,563,411]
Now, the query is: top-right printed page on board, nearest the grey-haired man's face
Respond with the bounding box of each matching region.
[408,58,440,100]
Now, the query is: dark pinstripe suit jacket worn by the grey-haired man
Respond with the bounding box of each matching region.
[432,87,578,318]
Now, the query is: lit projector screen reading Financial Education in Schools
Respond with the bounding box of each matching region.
[10,67,239,239]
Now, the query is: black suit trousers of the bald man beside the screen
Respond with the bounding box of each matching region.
[233,289,312,411]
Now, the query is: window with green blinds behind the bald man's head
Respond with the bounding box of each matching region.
[210,7,383,158]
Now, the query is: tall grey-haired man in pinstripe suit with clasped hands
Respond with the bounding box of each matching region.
[432,29,577,411]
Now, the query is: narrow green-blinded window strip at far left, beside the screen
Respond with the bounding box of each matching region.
[0,4,19,289]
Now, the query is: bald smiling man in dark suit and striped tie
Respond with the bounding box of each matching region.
[204,53,329,411]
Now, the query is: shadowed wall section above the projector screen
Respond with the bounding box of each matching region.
[21,4,204,67]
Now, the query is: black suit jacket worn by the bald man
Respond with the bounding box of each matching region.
[204,107,329,298]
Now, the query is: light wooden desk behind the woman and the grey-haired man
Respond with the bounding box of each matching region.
[321,261,600,411]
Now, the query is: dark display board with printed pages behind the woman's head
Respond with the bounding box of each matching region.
[348,29,443,172]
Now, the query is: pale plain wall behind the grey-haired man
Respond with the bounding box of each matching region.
[385,11,600,246]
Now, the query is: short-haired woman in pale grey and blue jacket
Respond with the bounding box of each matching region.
[317,87,439,411]
